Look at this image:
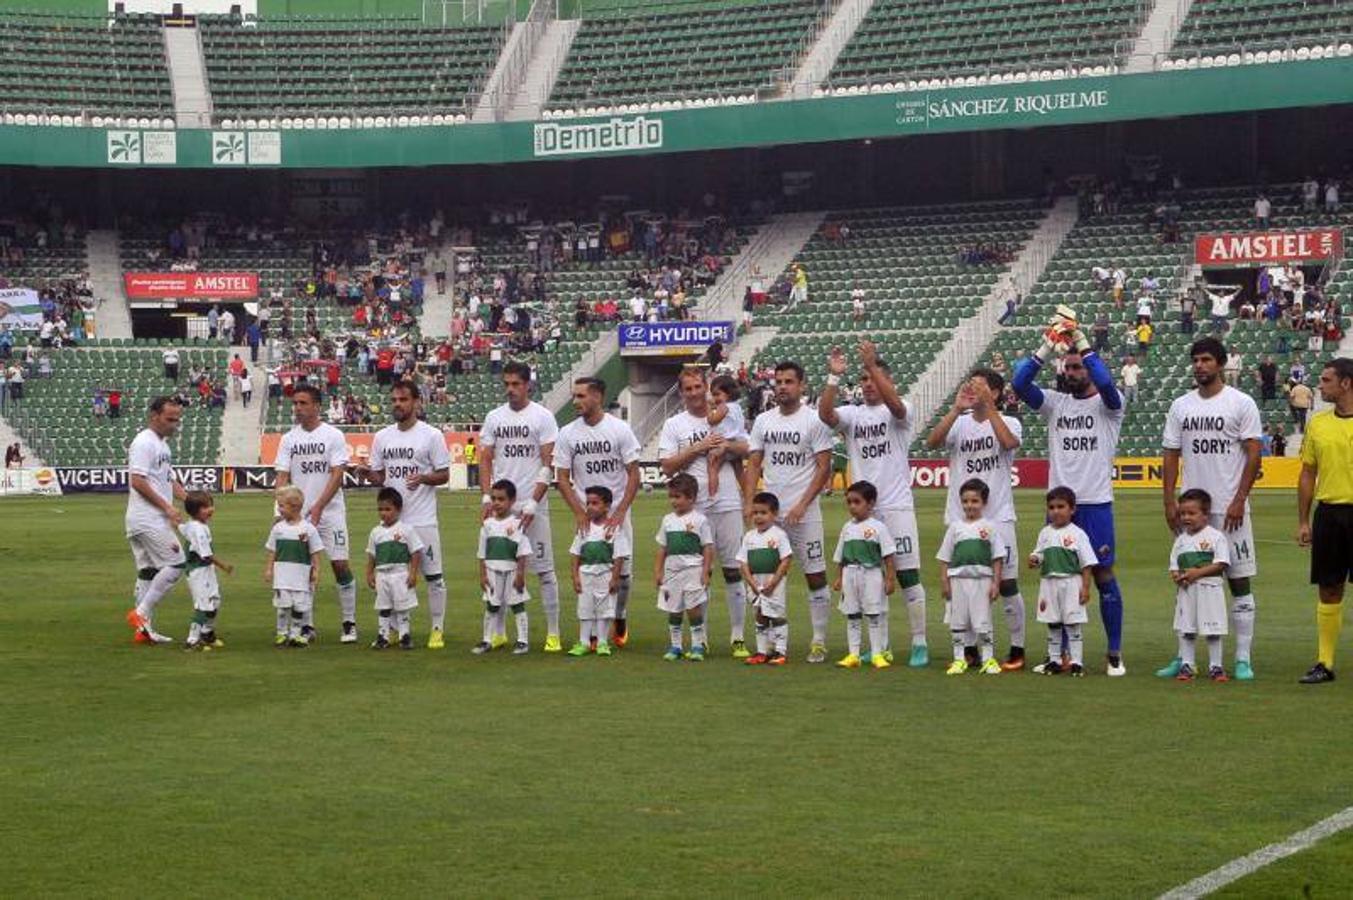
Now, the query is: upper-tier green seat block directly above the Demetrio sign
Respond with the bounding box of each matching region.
[547,0,823,110]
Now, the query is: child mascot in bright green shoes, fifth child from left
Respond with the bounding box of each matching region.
[568,485,630,656]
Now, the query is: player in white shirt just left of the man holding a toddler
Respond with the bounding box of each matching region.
[555,378,640,647]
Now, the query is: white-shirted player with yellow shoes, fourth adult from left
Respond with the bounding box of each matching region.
[479,361,563,654]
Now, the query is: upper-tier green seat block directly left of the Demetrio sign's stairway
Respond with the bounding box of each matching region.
[199,16,505,125]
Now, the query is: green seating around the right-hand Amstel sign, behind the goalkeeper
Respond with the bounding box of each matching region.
[912,184,1353,457]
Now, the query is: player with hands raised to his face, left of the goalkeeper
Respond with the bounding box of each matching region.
[925,368,1024,671]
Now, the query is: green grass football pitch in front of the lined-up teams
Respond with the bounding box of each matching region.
[0,491,1353,897]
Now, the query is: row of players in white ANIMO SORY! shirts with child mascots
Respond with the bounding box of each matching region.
[126,326,1353,679]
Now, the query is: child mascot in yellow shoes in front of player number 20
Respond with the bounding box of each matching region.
[832,482,897,669]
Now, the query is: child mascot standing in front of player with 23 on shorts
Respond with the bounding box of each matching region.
[737,491,794,666]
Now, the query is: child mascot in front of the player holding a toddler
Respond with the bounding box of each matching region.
[653,472,714,662]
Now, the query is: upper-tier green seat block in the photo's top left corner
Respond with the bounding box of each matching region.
[0,11,173,118]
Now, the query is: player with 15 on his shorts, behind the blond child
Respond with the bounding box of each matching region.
[273,384,357,644]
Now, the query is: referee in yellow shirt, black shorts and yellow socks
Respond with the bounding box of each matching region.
[1296,359,1353,685]
